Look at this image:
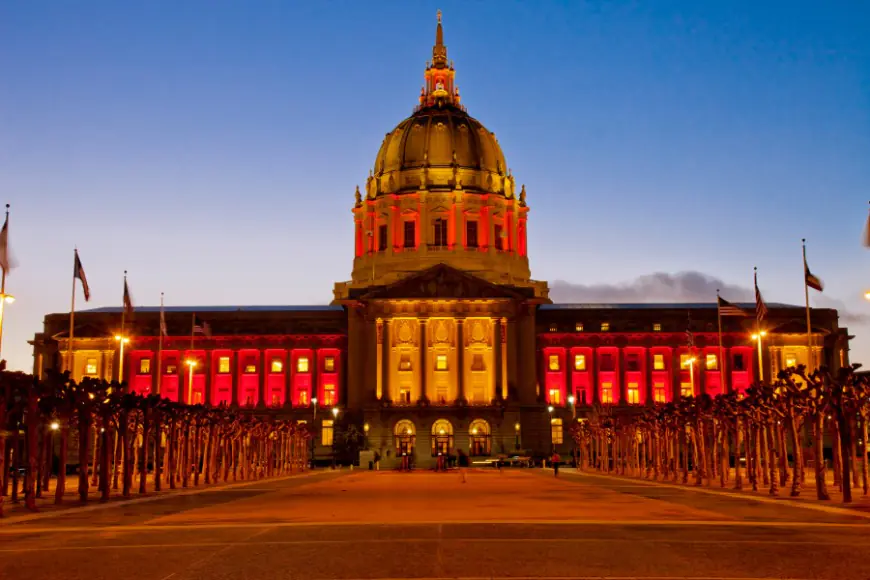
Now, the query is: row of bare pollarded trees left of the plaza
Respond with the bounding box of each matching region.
[0,363,309,516]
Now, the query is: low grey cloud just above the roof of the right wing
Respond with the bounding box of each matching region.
[550,271,755,303]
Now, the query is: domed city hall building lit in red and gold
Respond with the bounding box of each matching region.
[32,15,849,467]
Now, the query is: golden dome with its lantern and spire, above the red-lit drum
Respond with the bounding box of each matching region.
[366,13,513,198]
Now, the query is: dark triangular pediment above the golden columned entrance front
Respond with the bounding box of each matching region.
[361,264,525,300]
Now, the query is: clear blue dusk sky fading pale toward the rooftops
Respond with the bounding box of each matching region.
[0,0,870,369]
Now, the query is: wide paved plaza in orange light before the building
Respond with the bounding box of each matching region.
[0,469,870,580]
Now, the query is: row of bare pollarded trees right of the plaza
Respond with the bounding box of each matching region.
[571,366,870,503]
